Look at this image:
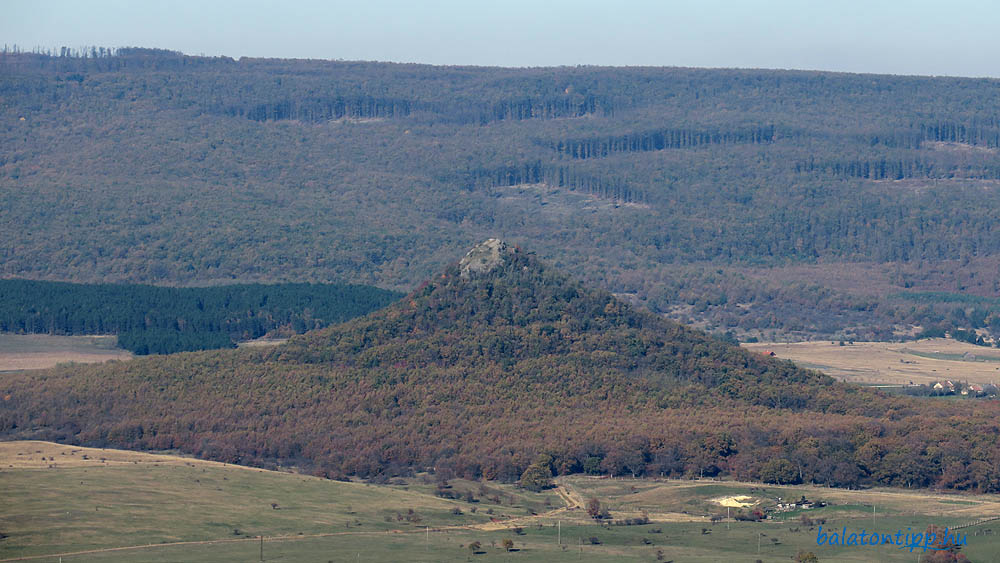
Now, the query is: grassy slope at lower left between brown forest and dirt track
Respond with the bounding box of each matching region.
[0,442,559,559]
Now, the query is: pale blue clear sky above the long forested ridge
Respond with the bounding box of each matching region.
[0,0,1000,78]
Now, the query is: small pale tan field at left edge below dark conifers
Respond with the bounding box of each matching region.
[0,334,132,372]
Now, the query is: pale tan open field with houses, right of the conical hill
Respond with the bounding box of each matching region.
[742,338,1000,385]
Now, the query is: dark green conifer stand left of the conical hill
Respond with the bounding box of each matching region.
[0,279,402,355]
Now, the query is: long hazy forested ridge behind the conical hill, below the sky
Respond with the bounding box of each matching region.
[0,48,1000,339]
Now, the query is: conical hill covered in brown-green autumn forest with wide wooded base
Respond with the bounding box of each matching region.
[0,242,1000,492]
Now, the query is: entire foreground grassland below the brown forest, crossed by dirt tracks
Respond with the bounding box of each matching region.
[0,442,1000,563]
